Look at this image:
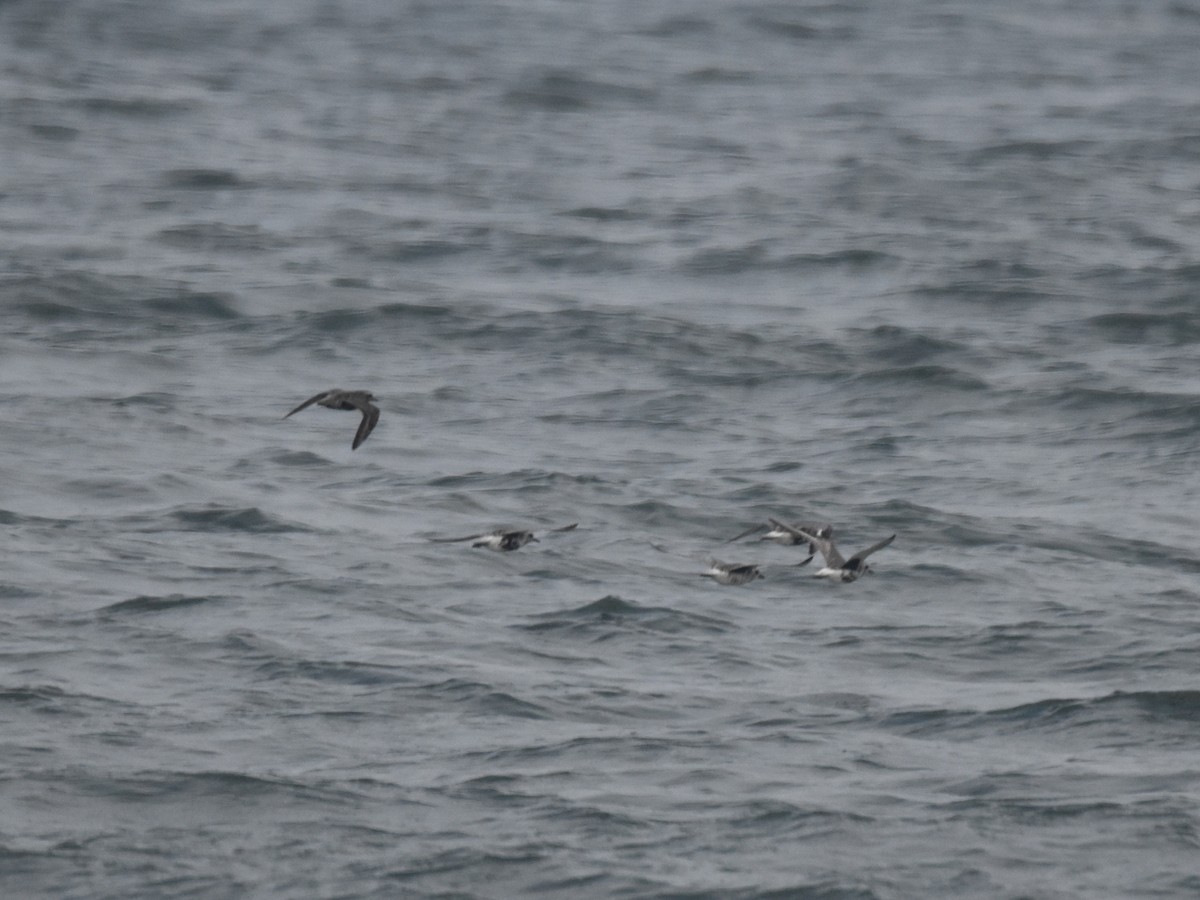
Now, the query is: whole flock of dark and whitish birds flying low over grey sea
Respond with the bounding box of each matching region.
[283,388,896,584]
